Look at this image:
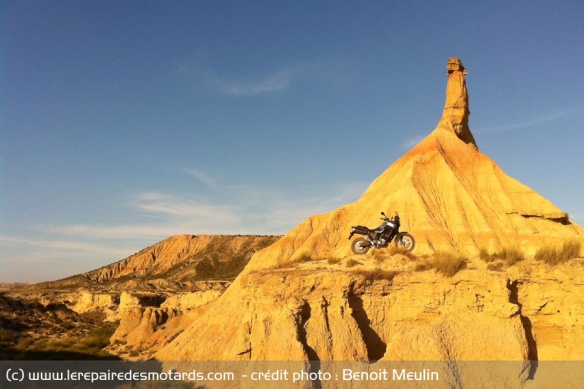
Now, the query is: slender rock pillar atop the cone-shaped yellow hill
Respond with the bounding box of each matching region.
[441,57,478,148]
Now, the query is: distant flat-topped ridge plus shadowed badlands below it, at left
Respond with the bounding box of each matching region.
[0,235,279,360]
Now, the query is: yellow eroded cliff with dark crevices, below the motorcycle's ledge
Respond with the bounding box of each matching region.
[149,254,584,387]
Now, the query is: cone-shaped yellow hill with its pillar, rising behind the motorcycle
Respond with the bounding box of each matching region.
[250,58,584,268]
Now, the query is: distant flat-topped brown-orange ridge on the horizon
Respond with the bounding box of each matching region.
[34,235,280,291]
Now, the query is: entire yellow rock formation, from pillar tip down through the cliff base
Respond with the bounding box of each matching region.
[148,59,584,387]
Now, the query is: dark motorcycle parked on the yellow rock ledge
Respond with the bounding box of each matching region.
[349,212,416,255]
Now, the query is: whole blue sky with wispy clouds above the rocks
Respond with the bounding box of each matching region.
[0,0,584,282]
